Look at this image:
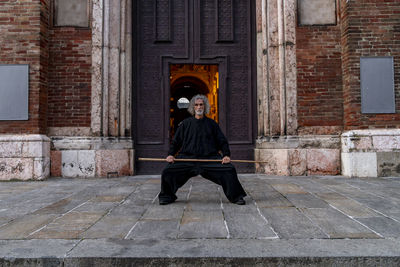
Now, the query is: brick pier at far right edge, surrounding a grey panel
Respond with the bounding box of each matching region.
[341,0,400,129]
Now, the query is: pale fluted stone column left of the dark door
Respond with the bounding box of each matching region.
[91,0,132,137]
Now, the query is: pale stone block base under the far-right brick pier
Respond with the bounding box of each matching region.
[341,129,400,177]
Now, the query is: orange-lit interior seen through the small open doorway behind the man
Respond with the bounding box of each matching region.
[169,64,219,140]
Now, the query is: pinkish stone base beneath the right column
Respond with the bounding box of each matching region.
[255,135,340,176]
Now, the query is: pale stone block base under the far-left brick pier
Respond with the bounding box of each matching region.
[0,135,50,180]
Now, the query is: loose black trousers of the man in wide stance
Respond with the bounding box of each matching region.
[158,162,246,202]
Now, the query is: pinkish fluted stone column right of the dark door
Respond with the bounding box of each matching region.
[257,0,297,136]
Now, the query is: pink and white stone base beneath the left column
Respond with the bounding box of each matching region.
[51,136,134,177]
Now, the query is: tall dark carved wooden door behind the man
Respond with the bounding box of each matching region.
[132,0,257,174]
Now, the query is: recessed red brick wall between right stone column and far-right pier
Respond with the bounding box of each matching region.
[296,25,343,134]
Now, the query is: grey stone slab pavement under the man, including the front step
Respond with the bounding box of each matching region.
[0,174,400,266]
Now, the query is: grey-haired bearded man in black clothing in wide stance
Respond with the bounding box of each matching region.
[159,95,246,205]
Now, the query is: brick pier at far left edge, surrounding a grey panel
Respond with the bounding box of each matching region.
[0,0,49,134]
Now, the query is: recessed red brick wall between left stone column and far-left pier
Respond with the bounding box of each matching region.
[48,27,92,127]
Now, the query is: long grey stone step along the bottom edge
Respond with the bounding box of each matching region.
[0,239,400,266]
